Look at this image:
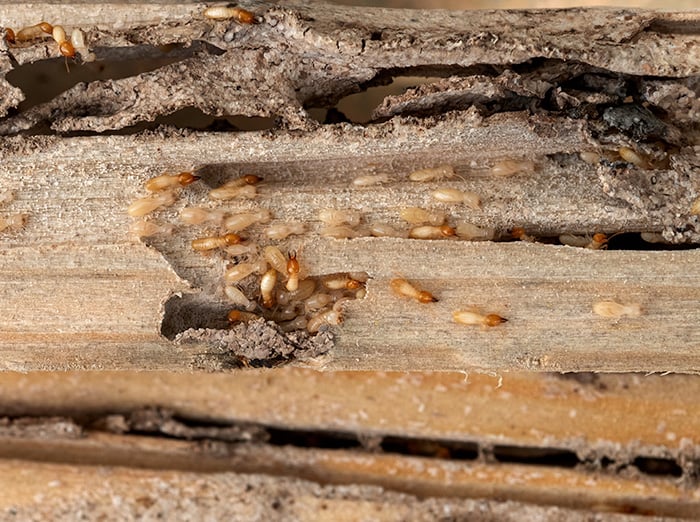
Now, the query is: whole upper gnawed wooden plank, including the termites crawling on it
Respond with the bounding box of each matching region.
[0,3,700,372]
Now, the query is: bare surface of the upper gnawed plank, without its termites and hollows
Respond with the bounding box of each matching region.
[0,4,700,372]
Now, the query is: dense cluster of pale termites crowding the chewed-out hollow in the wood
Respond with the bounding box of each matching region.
[127,172,367,334]
